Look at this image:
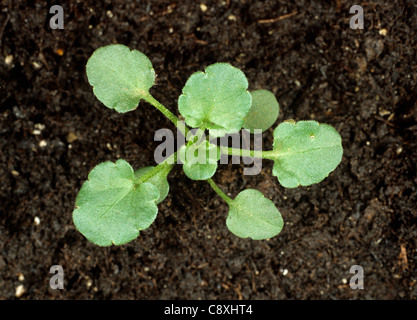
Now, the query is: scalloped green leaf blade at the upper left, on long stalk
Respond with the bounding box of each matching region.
[87,44,155,113]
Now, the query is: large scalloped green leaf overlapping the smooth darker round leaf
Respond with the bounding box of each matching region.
[178,63,252,137]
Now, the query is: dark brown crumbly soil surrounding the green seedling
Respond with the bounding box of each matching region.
[0,0,417,299]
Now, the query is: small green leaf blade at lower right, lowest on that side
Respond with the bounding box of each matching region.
[226,189,284,240]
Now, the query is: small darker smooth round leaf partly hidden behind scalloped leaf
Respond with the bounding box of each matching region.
[243,90,279,133]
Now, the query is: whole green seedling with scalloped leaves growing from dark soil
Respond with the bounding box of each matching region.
[73,45,343,246]
